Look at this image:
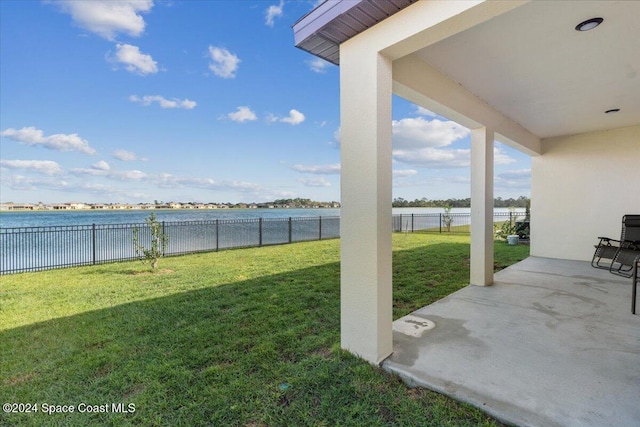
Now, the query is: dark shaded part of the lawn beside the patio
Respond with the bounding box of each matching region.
[0,244,504,426]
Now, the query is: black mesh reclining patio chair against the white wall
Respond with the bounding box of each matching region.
[591,215,640,277]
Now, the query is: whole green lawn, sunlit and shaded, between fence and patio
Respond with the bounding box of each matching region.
[0,233,528,426]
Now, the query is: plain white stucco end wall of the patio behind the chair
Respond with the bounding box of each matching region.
[531,126,640,261]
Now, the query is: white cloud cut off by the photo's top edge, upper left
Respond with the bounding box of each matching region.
[57,0,153,40]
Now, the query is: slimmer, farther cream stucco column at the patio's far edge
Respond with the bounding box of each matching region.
[471,128,493,286]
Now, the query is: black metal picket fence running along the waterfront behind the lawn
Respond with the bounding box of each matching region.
[0,212,524,274]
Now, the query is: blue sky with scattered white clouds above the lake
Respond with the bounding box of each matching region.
[0,0,530,203]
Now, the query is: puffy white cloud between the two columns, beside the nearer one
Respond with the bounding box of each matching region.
[392,117,469,150]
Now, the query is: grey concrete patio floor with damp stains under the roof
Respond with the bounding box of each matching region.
[382,257,640,427]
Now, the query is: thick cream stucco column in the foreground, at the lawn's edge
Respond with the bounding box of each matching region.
[340,45,393,364]
